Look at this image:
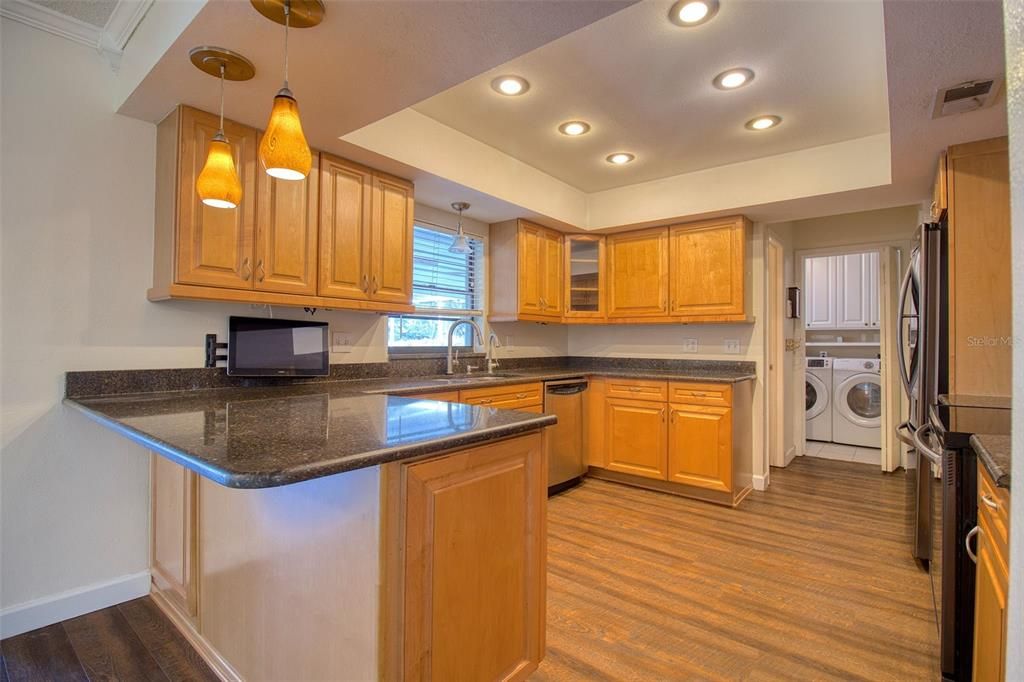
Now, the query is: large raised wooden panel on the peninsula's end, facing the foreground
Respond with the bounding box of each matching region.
[393,433,548,680]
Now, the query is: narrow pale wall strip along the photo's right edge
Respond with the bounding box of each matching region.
[1002,0,1024,680]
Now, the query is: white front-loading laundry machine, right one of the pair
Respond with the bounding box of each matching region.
[833,357,882,447]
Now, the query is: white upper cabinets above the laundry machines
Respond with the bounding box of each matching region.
[804,252,880,330]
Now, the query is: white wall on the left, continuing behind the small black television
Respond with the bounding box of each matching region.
[0,19,566,625]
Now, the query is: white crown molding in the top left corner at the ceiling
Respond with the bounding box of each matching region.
[0,0,154,71]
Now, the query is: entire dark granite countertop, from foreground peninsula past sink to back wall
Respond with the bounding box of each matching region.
[65,360,756,488]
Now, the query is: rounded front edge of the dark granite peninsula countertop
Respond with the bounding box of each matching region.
[62,398,557,489]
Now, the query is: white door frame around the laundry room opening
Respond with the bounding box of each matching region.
[793,238,910,472]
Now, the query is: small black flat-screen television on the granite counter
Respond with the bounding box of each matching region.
[227,315,331,377]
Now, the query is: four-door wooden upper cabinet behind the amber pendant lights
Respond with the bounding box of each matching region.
[148,106,413,312]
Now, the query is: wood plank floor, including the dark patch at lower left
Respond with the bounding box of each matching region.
[0,458,939,682]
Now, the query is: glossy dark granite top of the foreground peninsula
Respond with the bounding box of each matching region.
[65,382,556,488]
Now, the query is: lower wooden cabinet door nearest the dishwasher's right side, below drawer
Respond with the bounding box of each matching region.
[604,398,667,480]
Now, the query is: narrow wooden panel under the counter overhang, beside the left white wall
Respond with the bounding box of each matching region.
[150,454,199,621]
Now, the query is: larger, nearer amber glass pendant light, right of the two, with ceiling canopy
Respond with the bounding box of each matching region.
[252,0,325,180]
